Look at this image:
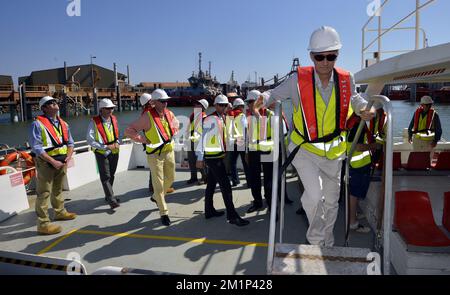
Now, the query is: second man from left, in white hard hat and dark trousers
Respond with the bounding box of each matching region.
[86,98,120,209]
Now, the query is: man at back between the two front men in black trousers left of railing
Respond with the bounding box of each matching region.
[227,98,250,187]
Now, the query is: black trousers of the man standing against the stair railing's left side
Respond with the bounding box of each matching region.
[248,151,273,207]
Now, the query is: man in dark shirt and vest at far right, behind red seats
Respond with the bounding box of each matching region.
[408,96,442,151]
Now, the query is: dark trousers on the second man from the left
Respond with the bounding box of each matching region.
[95,153,119,201]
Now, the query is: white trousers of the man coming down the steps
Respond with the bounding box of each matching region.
[292,149,342,247]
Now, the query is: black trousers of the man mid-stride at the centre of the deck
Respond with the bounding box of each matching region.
[205,159,238,219]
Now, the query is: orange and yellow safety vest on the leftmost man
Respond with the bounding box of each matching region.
[36,116,69,157]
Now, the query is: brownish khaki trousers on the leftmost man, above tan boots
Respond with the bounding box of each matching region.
[35,157,67,227]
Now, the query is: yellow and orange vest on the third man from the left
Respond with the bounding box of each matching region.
[145,108,175,155]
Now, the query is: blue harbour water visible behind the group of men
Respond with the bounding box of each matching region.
[0,101,450,146]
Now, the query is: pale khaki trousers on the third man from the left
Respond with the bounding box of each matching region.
[147,151,175,216]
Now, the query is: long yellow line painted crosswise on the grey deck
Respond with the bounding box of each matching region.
[76,229,268,250]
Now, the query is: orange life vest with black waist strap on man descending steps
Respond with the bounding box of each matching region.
[294,67,352,143]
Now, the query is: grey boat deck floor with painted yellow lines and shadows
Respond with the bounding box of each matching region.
[0,169,374,275]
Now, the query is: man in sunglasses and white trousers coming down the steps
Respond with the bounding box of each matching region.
[258,26,375,246]
